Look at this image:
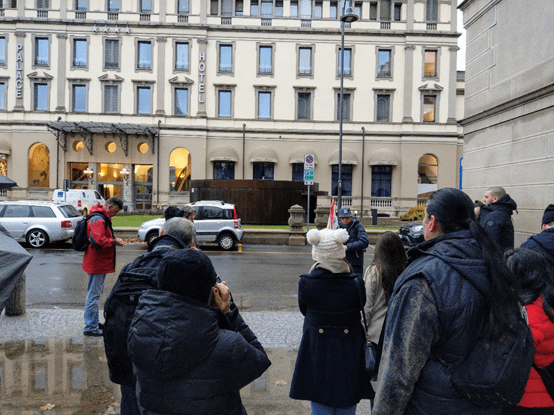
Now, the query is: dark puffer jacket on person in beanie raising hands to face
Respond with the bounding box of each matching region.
[127,290,271,415]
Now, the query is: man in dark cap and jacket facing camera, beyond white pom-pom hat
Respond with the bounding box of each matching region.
[339,207,369,275]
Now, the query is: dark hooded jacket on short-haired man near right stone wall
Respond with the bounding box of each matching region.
[479,195,517,252]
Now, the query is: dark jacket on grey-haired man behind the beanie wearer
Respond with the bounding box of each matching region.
[104,249,163,386]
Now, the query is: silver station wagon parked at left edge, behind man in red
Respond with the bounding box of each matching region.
[0,200,83,248]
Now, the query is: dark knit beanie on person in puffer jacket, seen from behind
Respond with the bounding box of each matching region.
[158,249,217,304]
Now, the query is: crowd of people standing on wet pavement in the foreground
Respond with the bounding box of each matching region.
[83,187,554,415]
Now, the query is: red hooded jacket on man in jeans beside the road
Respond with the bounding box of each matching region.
[82,205,115,274]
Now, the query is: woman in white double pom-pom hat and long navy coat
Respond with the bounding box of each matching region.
[290,229,373,415]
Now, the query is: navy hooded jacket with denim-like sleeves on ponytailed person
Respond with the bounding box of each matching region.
[372,231,500,415]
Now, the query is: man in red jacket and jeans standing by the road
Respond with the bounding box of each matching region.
[82,197,124,336]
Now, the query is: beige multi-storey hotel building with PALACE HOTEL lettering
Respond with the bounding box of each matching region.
[0,0,464,216]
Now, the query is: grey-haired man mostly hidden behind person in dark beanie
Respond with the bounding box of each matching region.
[104,217,196,415]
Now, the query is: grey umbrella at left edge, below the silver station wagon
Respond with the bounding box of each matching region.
[0,226,33,312]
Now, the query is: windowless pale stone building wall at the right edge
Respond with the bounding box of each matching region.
[460,0,554,246]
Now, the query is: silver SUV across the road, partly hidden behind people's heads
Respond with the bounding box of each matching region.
[138,200,244,251]
